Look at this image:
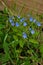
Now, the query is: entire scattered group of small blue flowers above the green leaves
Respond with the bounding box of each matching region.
[9,16,41,39]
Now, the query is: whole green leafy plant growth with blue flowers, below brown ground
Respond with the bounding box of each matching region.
[0,9,43,65]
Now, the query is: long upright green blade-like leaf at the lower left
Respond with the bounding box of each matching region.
[3,34,10,61]
